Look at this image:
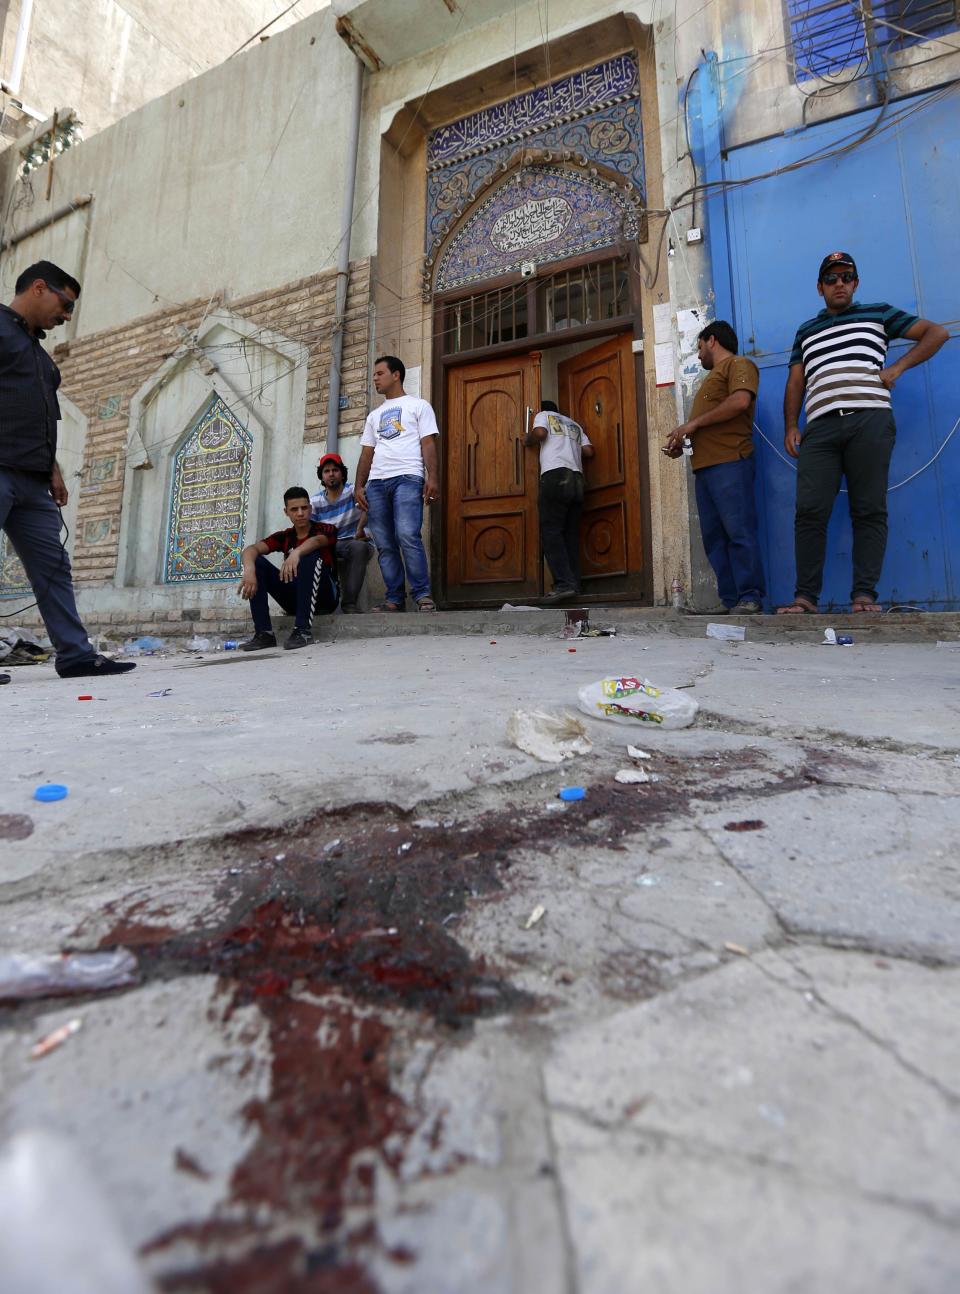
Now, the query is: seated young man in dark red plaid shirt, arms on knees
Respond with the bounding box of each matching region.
[237,485,340,651]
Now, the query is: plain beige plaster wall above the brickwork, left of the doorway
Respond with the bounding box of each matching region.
[0,10,376,328]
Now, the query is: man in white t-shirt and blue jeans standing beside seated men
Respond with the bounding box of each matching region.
[353,355,440,611]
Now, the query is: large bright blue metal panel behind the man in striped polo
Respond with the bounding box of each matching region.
[701,84,960,609]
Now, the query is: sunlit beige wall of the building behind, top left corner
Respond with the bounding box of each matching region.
[0,0,330,137]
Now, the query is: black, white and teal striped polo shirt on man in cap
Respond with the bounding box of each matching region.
[791,302,917,423]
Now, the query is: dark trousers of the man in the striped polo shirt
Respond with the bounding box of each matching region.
[794,409,897,602]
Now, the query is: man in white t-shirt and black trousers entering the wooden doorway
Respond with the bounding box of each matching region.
[527,400,594,603]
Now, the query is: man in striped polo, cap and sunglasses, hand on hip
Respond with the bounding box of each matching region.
[779,251,950,613]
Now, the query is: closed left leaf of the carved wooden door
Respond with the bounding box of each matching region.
[445,352,541,602]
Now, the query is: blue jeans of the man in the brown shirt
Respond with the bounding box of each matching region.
[693,454,766,607]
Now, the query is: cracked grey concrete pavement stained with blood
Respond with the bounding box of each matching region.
[0,628,960,1294]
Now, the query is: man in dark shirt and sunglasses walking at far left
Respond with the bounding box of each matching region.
[0,260,135,678]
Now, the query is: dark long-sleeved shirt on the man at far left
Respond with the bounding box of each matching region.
[0,305,60,476]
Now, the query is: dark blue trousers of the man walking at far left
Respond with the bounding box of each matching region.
[0,467,96,669]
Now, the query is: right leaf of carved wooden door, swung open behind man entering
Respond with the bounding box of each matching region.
[556,335,644,594]
